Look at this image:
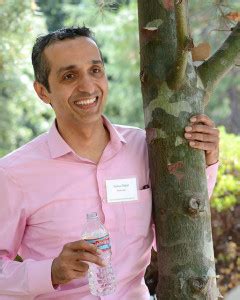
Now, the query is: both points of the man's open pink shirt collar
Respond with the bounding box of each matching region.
[47,116,126,158]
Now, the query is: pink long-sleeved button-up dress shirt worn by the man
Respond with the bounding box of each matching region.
[0,117,217,300]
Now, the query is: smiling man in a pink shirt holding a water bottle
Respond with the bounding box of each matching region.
[0,27,218,300]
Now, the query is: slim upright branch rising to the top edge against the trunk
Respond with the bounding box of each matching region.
[167,0,190,90]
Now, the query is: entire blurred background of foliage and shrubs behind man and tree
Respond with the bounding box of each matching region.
[0,0,240,293]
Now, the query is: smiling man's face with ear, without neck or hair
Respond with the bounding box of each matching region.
[35,37,108,129]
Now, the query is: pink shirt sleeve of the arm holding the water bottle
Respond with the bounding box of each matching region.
[0,168,55,299]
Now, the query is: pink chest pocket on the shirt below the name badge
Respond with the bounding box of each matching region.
[123,188,152,237]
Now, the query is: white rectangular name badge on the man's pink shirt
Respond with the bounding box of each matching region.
[106,178,138,203]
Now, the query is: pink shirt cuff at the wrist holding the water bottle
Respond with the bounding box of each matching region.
[27,259,56,295]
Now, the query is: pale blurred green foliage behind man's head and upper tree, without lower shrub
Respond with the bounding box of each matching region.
[0,0,239,156]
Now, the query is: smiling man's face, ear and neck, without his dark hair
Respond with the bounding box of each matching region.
[33,32,109,163]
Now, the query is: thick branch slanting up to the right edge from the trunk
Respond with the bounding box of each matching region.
[197,22,240,97]
